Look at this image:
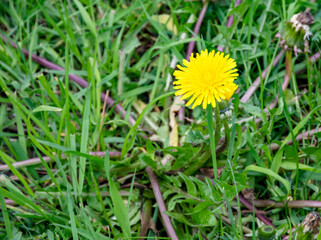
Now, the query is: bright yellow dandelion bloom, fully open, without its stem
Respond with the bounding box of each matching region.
[173,49,238,109]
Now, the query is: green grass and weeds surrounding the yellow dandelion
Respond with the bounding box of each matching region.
[0,0,321,240]
